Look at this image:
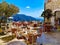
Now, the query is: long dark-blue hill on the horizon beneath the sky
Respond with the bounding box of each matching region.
[8,14,43,21]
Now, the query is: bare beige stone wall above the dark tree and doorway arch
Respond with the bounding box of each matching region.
[45,0,60,11]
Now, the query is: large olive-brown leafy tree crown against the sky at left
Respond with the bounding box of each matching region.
[0,1,19,20]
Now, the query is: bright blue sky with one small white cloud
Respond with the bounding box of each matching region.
[0,0,44,17]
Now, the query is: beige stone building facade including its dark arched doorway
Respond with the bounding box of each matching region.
[45,0,60,24]
